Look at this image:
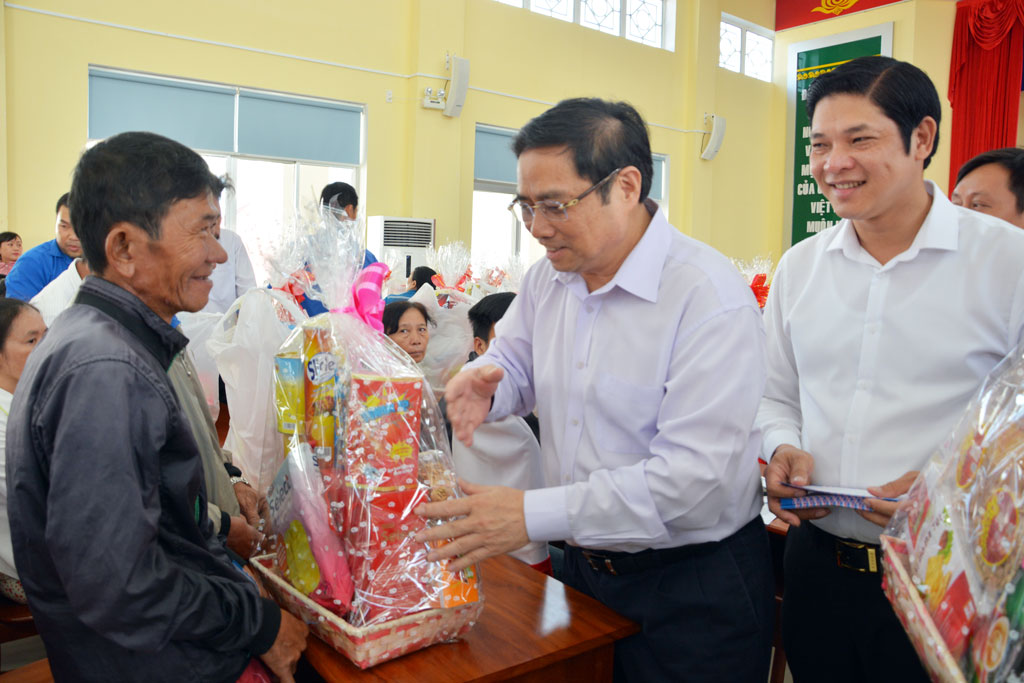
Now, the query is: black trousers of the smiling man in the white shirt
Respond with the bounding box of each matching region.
[782,521,929,683]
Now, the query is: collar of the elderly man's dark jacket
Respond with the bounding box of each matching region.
[76,275,188,370]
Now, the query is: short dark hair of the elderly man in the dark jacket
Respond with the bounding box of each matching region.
[70,132,228,273]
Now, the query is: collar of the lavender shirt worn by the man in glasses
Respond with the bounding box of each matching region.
[554,199,675,303]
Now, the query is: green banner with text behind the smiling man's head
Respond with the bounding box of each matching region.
[793,36,882,244]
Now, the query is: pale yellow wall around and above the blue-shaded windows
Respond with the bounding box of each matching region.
[0,0,717,252]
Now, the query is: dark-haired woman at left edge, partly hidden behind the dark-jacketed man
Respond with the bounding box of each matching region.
[0,299,46,604]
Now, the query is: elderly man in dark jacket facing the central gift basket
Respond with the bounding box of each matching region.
[7,133,307,683]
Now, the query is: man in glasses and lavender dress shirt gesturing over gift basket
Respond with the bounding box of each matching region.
[418,99,773,683]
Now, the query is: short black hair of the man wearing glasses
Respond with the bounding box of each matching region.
[512,97,654,202]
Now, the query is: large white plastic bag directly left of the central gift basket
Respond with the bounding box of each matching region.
[207,289,306,496]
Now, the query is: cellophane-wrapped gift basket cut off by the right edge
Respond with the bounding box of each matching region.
[882,351,1024,683]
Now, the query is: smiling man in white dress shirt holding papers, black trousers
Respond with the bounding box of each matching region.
[758,57,1024,683]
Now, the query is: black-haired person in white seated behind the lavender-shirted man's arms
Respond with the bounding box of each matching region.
[452,292,551,574]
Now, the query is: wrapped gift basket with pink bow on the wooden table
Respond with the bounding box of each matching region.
[255,205,482,668]
